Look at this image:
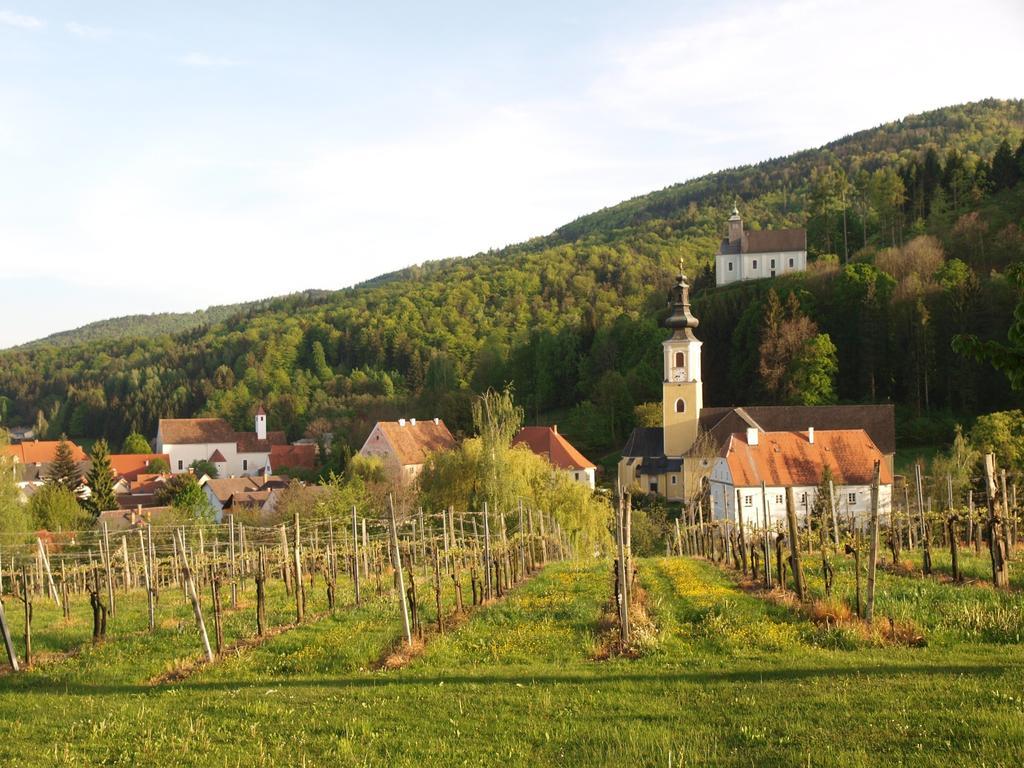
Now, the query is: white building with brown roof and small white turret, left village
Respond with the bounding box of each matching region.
[157,407,288,477]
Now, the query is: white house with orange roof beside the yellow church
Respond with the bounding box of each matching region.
[709,427,893,527]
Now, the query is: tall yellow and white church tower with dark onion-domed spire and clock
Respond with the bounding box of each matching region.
[662,261,703,458]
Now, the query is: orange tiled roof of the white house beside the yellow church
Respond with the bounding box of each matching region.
[723,429,893,487]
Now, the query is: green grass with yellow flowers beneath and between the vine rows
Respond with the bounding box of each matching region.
[0,558,1024,768]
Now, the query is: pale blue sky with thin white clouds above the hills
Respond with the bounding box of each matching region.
[0,0,1024,348]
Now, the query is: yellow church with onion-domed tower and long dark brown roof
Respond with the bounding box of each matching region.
[617,266,896,514]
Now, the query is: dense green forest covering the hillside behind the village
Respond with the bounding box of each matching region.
[0,100,1024,458]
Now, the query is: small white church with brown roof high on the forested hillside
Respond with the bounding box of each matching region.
[715,207,807,286]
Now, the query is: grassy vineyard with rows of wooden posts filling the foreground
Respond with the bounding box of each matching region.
[0,487,1024,766]
